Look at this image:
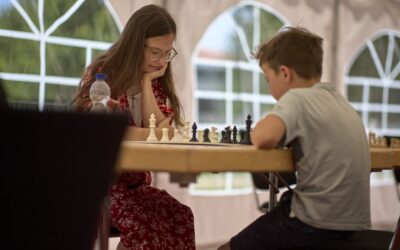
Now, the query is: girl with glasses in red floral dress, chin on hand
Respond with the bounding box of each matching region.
[73,5,195,250]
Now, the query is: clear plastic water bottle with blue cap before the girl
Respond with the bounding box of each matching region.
[89,73,110,112]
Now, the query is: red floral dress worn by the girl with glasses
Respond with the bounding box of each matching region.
[110,80,195,250]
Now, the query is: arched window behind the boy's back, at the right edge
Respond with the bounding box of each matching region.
[344,30,400,182]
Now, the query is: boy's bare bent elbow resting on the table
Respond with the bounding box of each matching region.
[251,115,286,149]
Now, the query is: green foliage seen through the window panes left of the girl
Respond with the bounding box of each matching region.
[0,0,119,105]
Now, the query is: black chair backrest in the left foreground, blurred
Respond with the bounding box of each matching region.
[0,110,127,250]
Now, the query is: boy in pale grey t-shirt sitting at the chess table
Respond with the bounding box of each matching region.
[219,28,370,250]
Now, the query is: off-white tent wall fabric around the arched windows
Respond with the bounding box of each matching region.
[111,0,400,246]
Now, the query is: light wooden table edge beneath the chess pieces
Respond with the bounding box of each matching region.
[117,142,400,173]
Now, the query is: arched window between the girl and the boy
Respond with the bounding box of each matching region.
[192,1,288,194]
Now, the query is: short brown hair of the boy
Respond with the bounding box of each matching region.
[256,27,323,79]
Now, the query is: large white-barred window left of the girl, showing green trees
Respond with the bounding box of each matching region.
[0,0,122,110]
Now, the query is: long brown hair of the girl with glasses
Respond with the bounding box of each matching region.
[72,4,183,125]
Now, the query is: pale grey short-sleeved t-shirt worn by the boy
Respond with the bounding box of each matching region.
[271,83,371,230]
